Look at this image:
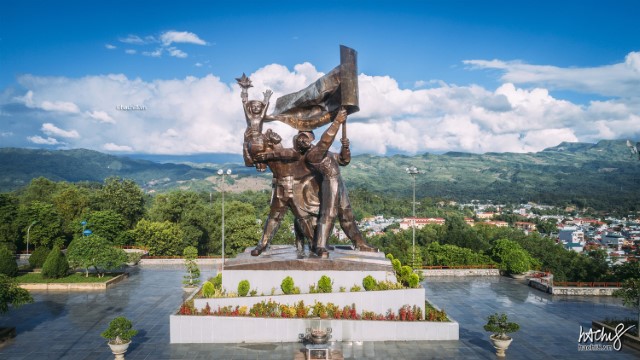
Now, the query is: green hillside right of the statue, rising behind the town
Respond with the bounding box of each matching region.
[343,140,640,210]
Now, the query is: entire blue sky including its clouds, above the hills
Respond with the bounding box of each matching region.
[0,0,640,155]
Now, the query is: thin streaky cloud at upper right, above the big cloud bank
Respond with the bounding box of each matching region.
[464,52,640,97]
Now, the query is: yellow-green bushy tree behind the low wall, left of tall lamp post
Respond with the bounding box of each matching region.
[133,219,189,256]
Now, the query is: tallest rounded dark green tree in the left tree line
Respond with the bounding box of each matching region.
[98,177,144,228]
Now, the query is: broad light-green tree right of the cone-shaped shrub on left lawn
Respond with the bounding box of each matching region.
[67,235,127,277]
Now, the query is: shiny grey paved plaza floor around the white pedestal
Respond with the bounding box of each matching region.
[0,267,640,360]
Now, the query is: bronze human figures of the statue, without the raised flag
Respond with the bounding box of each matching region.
[237,74,378,258]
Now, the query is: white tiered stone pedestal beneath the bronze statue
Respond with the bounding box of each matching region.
[170,246,459,343]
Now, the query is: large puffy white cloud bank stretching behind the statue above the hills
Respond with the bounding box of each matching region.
[6,53,640,155]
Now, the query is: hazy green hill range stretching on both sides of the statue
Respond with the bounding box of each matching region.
[0,140,640,211]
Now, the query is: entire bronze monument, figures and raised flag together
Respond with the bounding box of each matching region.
[236,46,377,257]
